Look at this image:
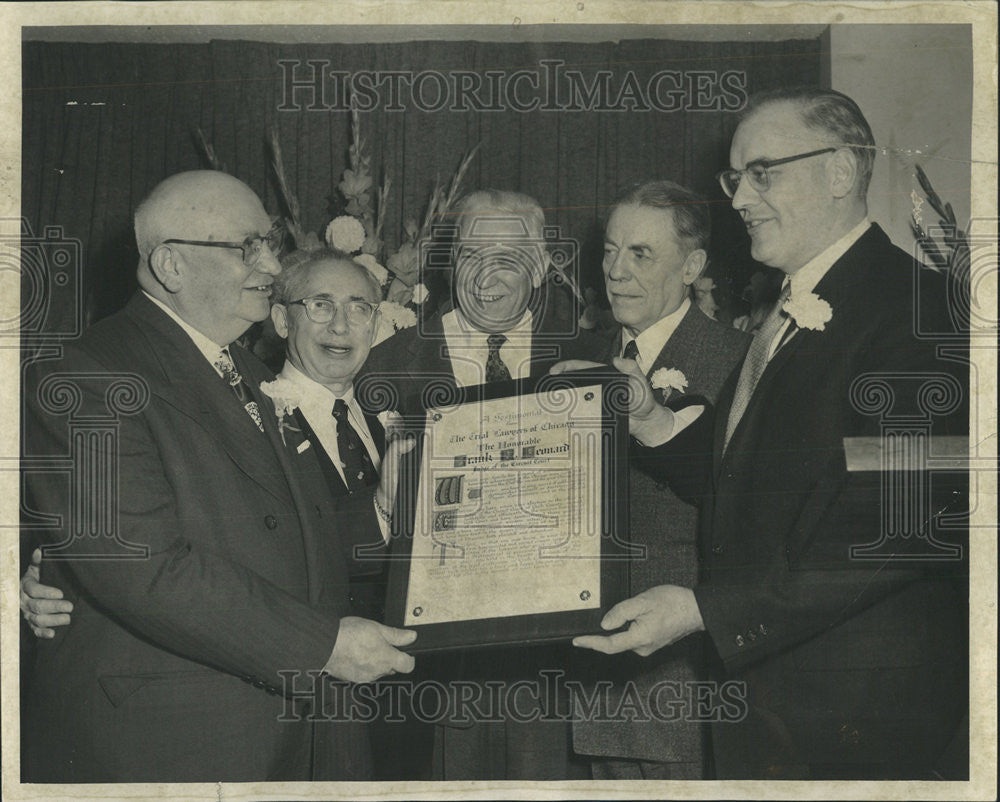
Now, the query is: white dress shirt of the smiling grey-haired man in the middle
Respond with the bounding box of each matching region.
[441,309,532,387]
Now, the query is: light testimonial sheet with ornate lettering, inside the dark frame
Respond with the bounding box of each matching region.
[404,385,605,626]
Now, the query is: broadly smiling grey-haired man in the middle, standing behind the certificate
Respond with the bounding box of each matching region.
[355,190,603,780]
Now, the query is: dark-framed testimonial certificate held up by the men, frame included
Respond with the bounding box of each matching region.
[386,368,628,651]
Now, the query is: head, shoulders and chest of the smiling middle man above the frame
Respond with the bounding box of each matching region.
[357,189,601,413]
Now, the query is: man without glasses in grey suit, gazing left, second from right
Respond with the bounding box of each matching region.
[573,181,749,780]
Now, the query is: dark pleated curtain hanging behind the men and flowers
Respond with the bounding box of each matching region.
[22,39,821,323]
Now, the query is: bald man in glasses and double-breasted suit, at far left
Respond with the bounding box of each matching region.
[22,172,413,782]
